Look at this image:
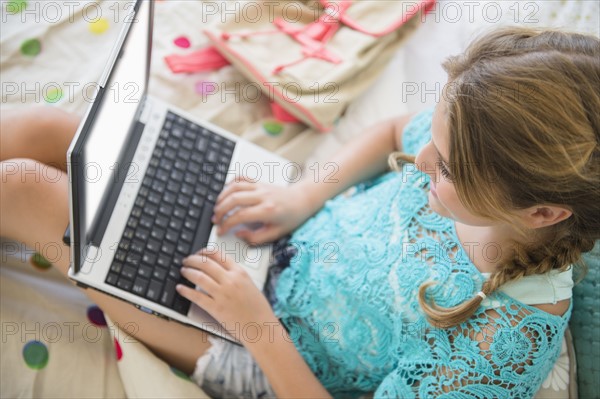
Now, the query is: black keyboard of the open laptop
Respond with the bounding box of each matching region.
[106,113,235,314]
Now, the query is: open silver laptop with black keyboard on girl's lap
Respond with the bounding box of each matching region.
[67,0,291,341]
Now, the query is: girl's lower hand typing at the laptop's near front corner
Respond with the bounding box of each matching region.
[177,249,277,343]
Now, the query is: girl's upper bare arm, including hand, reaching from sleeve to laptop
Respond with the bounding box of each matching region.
[213,116,411,244]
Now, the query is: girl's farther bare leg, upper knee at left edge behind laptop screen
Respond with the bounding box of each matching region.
[0,106,80,170]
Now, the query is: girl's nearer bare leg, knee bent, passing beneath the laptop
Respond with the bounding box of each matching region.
[0,108,210,373]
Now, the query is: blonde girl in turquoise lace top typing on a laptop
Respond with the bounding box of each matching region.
[0,28,600,398]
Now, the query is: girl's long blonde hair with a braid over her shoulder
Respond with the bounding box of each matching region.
[392,27,600,328]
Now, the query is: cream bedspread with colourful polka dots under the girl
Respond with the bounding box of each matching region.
[0,0,600,398]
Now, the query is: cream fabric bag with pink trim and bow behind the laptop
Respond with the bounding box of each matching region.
[166,0,435,131]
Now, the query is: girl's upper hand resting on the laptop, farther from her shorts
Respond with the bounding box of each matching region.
[213,178,317,245]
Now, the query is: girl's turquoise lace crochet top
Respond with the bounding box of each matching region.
[275,110,571,399]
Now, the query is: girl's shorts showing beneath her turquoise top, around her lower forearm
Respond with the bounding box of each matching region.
[191,237,296,398]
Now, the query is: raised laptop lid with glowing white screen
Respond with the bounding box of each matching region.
[67,0,154,272]
